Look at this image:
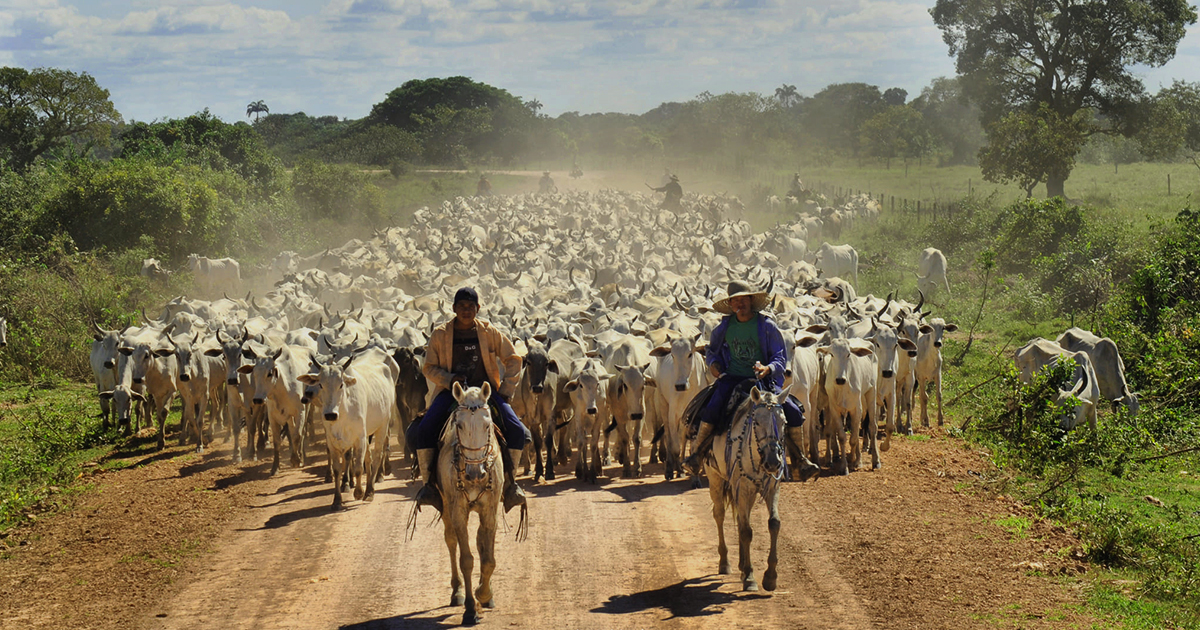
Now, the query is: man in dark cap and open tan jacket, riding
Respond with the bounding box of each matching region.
[407,288,530,511]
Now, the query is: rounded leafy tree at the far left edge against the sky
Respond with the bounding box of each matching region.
[0,67,121,172]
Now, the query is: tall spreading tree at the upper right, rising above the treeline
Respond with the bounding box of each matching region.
[930,0,1196,197]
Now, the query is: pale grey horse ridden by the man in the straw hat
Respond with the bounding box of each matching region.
[707,386,786,590]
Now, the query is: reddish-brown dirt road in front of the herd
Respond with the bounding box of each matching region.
[0,438,1088,630]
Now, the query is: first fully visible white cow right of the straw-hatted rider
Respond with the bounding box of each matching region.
[817,340,883,475]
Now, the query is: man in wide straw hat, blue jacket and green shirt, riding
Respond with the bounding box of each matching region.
[684,281,816,476]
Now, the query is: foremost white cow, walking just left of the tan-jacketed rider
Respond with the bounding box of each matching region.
[296,348,400,510]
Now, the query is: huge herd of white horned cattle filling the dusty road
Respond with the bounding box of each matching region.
[79,191,1136,508]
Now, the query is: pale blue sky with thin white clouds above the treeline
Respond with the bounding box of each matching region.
[0,0,1200,121]
